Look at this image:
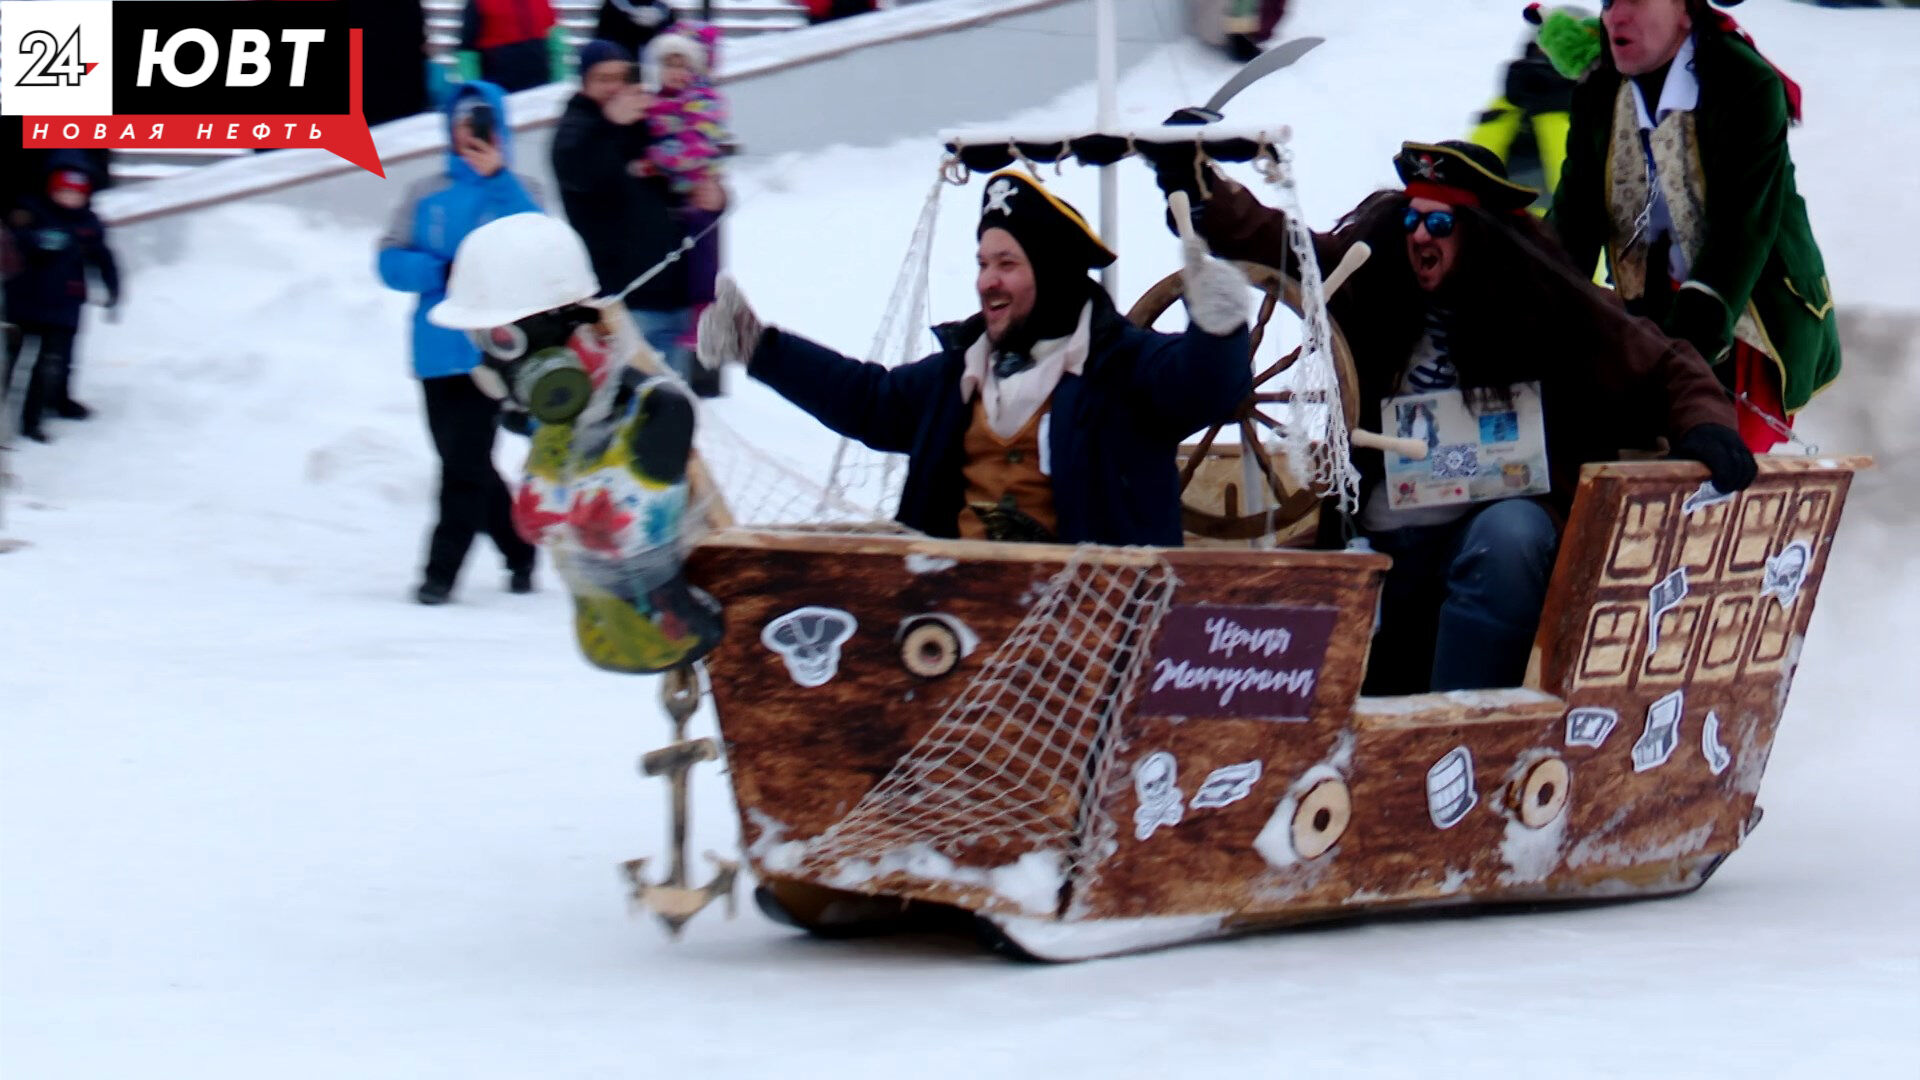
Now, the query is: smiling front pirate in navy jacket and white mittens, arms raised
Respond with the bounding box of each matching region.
[699,171,1252,546]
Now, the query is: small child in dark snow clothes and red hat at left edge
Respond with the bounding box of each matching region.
[6,169,119,442]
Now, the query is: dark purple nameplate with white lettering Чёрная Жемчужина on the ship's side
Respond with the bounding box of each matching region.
[1137,603,1338,723]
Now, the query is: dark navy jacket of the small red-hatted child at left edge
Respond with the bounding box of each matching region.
[6,196,119,331]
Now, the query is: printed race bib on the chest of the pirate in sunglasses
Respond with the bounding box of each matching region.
[1380,382,1551,509]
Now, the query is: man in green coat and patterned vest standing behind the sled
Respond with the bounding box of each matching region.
[1542,0,1839,452]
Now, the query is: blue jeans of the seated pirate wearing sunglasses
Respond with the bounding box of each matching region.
[1365,500,1559,694]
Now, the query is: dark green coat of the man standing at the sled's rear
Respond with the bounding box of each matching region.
[1549,31,1839,413]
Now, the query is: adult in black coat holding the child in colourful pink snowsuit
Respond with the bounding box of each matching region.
[553,40,691,377]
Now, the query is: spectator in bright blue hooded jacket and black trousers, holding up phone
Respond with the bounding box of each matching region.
[380,83,540,603]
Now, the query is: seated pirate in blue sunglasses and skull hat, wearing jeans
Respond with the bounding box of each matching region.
[1156,142,1755,694]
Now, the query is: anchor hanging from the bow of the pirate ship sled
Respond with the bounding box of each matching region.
[622,665,739,938]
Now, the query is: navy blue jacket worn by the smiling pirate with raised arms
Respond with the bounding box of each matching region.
[747,288,1254,548]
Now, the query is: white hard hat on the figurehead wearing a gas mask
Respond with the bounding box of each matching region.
[426,213,599,331]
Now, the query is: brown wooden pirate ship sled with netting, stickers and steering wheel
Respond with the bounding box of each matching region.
[587,129,1870,959]
